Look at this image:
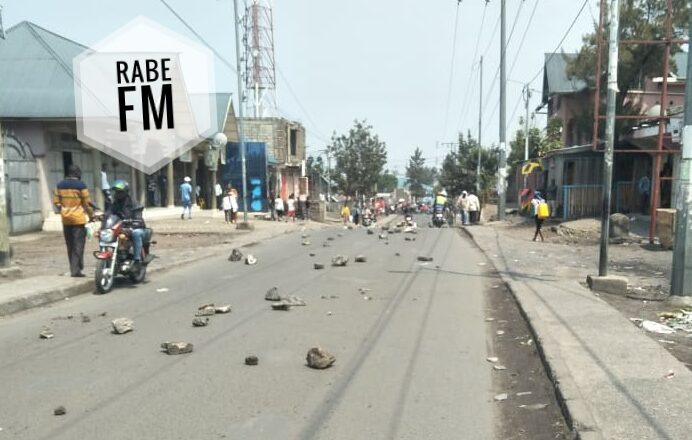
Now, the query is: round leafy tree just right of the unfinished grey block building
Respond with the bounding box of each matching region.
[328,119,387,196]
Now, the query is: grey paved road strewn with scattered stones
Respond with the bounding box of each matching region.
[0,218,496,440]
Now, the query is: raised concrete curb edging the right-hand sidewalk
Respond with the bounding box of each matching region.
[460,227,603,440]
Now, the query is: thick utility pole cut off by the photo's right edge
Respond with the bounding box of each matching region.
[670,2,692,297]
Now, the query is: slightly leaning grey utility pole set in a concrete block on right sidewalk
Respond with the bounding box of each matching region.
[596,0,620,277]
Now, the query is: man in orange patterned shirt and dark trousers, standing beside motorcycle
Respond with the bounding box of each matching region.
[53,165,94,277]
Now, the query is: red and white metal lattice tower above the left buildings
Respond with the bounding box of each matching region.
[243,0,278,118]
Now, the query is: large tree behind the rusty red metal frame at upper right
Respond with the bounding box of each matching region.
[568,0,688,139]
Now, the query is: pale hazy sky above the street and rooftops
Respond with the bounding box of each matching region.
[0,0,598,173]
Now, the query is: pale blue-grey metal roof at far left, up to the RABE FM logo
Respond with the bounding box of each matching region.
[0,21,87,119]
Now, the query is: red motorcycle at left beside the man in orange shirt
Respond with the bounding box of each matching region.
[94,215,156,293]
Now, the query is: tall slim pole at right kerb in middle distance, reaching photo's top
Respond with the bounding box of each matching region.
[497,0,507,220]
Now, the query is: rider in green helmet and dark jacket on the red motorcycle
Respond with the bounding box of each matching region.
[102,179,146,272]
